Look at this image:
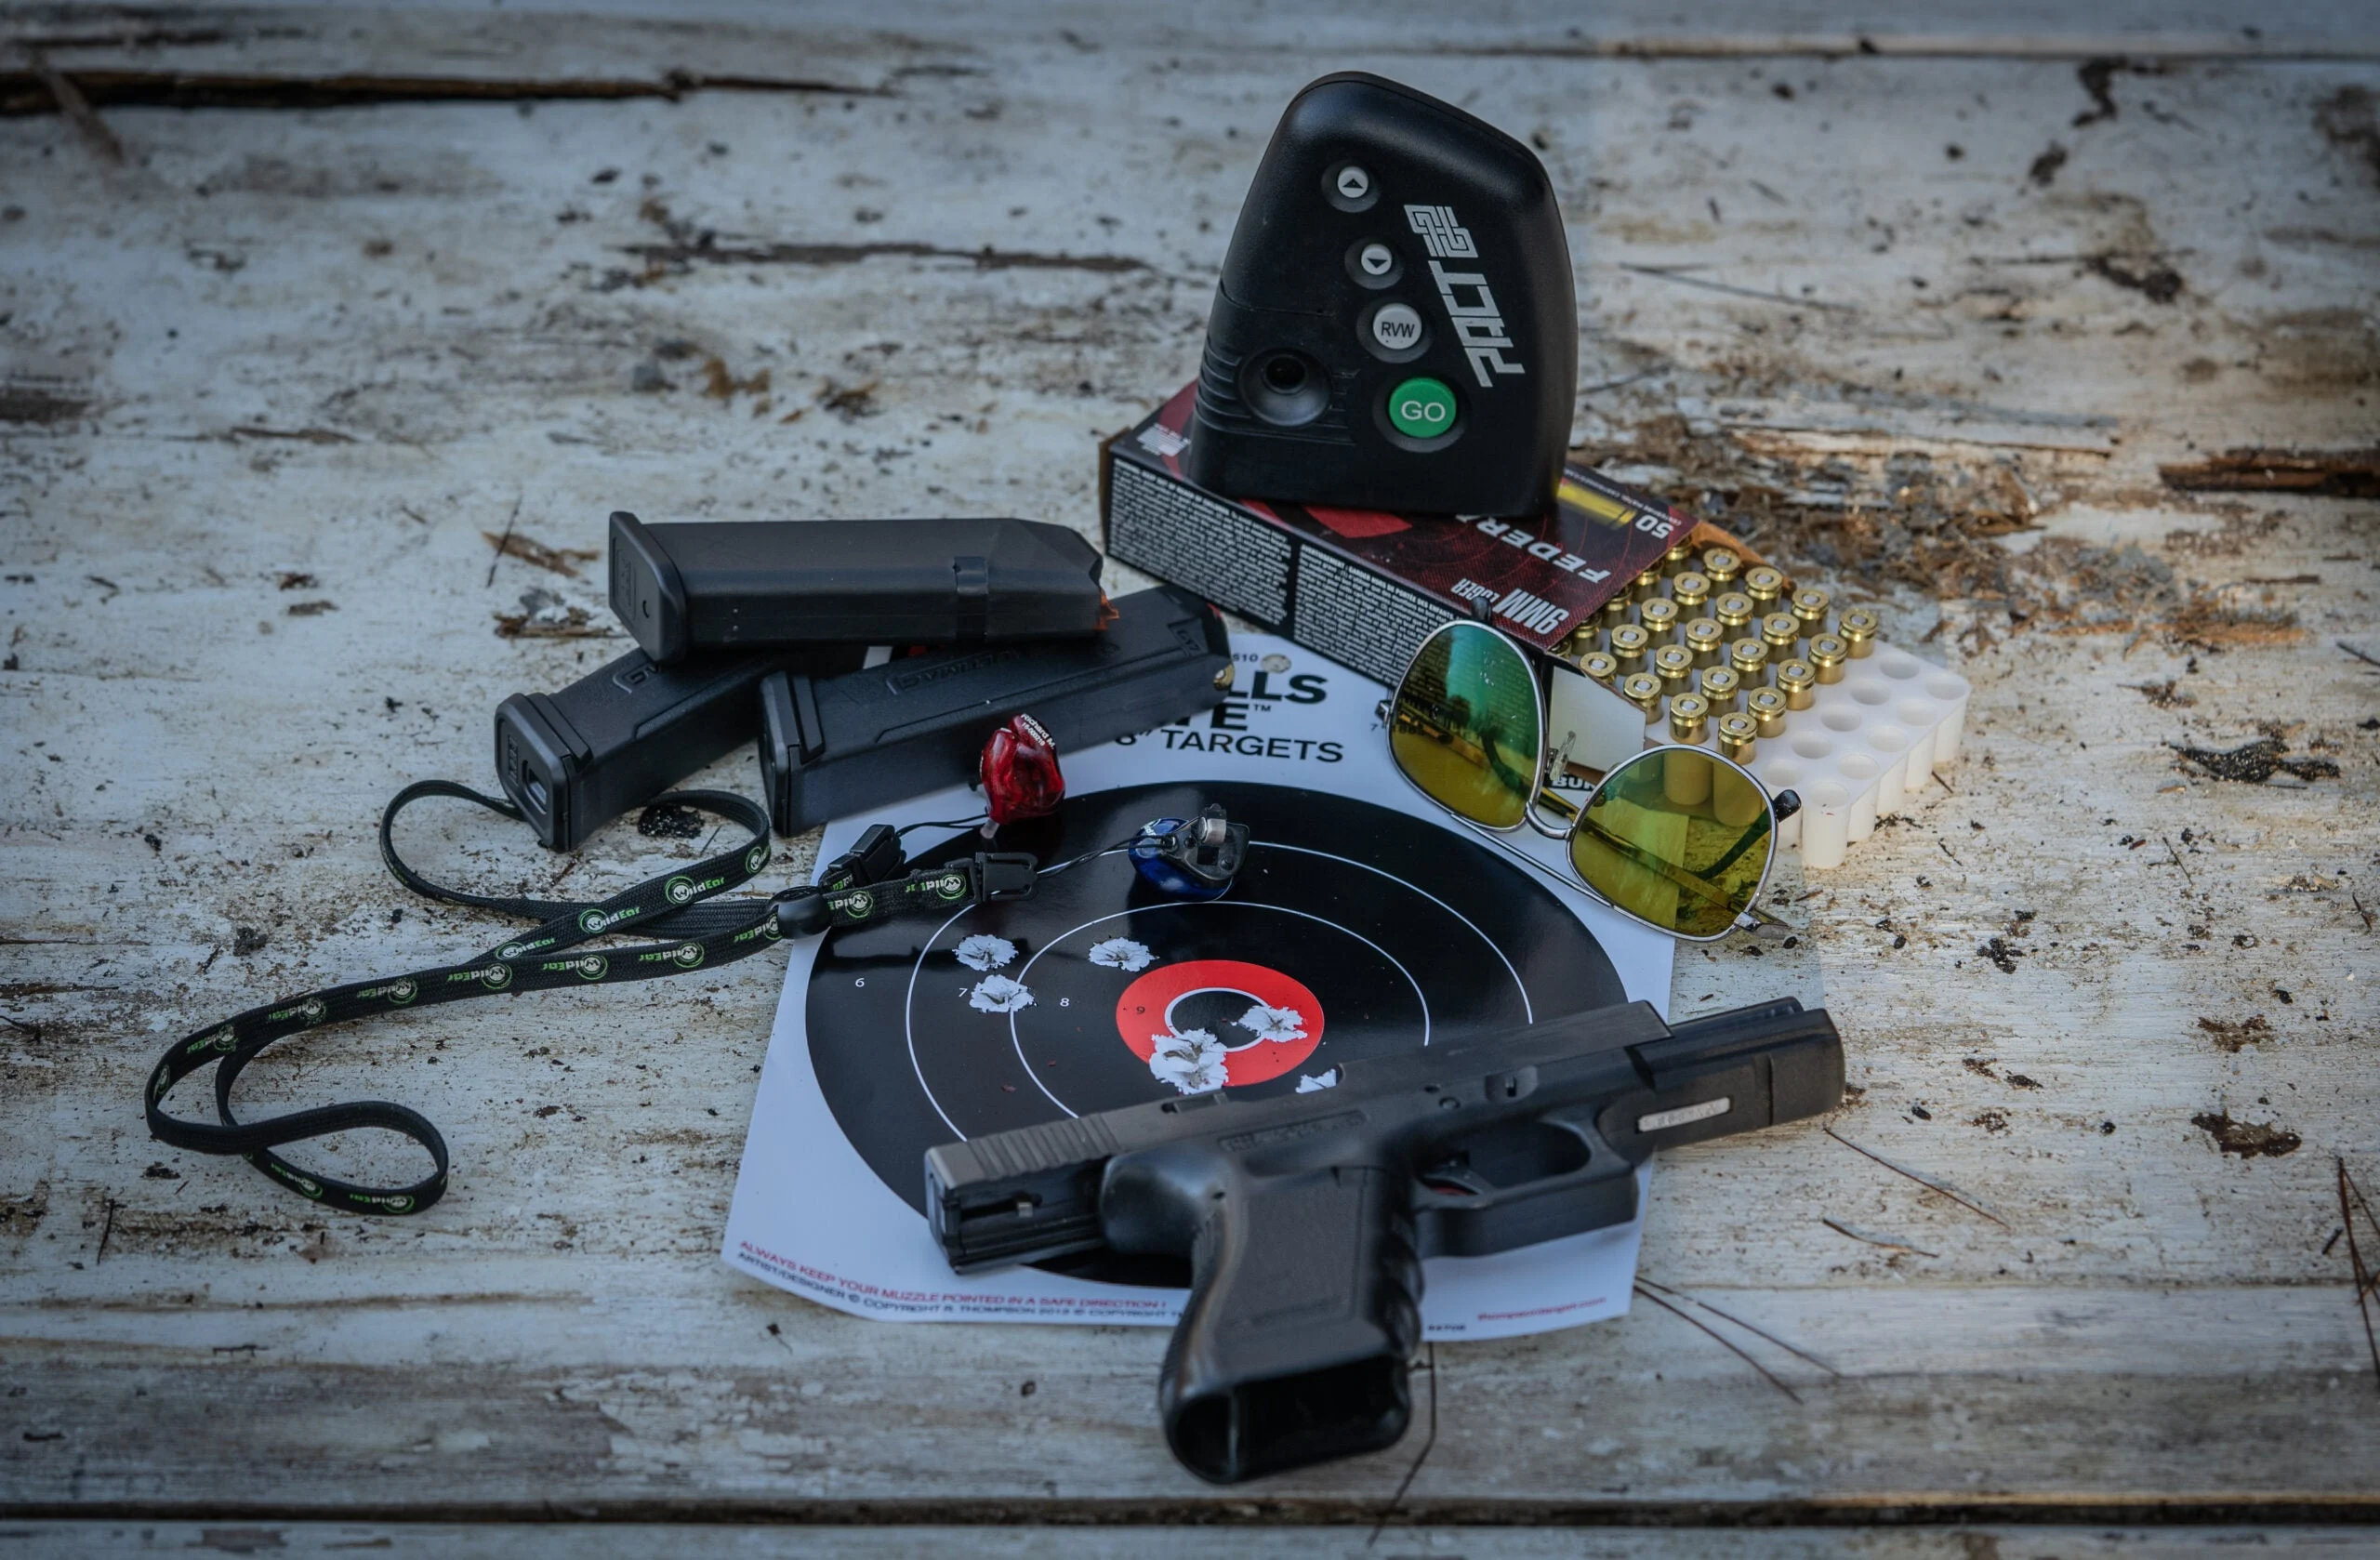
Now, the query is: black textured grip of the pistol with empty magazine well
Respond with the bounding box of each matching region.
[1109,1155,1421,1484]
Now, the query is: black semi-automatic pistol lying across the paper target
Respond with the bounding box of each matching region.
[926,998,1842,1484]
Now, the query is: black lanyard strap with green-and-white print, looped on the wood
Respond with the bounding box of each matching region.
[143,781,1036,1215]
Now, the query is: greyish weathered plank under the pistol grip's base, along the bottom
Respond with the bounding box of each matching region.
[0,1266,2380,1522]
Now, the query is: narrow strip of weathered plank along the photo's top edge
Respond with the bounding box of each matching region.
[9,0,2380,84]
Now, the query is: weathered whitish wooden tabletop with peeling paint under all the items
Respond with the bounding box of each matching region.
[0,7,2380,1555]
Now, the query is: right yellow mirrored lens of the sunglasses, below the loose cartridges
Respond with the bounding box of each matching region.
[1571,747,1776,936]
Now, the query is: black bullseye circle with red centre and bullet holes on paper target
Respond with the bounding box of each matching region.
[807,781,1625,1276]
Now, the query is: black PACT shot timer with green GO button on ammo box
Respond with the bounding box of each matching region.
[1185,72,1578,514]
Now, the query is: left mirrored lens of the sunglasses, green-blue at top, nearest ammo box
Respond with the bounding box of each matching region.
[1387,624,1544,829]
